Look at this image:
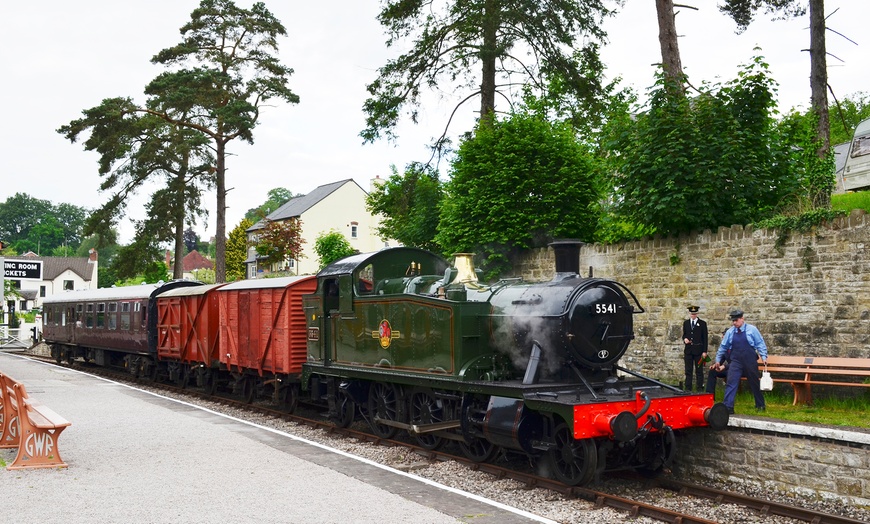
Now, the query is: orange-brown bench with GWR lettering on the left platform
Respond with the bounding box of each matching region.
[0,374,70,470]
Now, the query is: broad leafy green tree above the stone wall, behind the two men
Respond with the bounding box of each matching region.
[609,58,798,234]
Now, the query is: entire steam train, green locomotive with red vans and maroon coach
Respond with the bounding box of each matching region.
[44,242,728,485]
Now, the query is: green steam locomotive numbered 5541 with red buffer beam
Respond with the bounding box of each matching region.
[302,242,728,485]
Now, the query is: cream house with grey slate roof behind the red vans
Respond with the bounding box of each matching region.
[245,178,398,278]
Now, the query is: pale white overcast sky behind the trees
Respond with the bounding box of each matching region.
[0,0,870,246]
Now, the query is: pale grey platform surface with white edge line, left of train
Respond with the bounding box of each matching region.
[0,351,552,524]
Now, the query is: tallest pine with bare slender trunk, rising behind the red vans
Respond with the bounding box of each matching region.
[145,0,299,282]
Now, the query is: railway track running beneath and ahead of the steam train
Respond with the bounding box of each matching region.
[29,355,864,524]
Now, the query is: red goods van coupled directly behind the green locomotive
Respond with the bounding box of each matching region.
[215,276,317,408]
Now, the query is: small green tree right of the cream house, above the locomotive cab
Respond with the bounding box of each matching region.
[366,162,444,252]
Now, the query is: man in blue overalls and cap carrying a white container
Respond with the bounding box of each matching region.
[714,309,767,413]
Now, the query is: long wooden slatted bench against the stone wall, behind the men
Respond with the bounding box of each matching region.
[758,355,870,405]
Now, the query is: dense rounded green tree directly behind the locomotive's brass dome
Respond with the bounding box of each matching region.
[436,108,598,277]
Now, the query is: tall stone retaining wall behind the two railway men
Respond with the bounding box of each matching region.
[515,210,870,381]
